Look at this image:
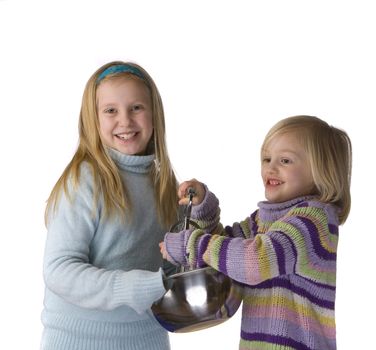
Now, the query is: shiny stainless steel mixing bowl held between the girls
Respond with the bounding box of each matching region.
[152,267,238,333]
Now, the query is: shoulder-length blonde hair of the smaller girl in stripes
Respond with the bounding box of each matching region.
[261,115,352,224]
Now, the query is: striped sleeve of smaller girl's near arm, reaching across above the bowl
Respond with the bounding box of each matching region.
[167,202,338,285]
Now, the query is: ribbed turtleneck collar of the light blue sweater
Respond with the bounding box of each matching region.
[107,148,155,174]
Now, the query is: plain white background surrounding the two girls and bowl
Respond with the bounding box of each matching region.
[0,0,376,350]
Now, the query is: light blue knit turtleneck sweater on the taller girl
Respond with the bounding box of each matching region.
[41,149,170,350]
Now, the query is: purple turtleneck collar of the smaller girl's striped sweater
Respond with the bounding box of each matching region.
[257,196,316,221]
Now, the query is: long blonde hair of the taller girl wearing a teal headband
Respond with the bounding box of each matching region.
[45,61,177,226]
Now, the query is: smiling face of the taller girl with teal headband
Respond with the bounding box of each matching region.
[97,78,153,155]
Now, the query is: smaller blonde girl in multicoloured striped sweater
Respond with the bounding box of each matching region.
[160,116,352,350]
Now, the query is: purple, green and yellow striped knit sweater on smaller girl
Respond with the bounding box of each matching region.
[165,191,338,350]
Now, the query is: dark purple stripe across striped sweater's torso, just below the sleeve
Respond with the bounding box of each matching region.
[247,277,334,310]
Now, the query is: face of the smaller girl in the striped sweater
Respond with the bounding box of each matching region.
[261,133,315,203]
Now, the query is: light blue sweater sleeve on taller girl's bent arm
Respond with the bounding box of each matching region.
[43,169,165,312]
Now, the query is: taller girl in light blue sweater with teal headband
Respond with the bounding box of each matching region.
[41,62,178,350]
